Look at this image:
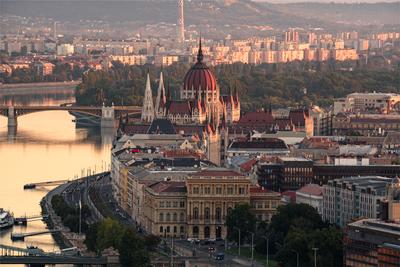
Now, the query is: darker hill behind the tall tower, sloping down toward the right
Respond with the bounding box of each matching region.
[1,0,332,31]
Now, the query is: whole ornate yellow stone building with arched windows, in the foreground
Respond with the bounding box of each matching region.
[139,168,281,239]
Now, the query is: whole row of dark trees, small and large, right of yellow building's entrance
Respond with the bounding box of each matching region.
[226,204,343,267]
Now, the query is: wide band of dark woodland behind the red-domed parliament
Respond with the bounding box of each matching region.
[76,61,400,111]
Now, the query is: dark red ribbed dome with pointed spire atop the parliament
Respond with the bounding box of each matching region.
[183,41,217,93]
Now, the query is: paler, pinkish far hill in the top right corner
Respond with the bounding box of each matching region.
[272,2,400,25]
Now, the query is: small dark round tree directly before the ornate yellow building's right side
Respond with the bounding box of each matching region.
[226,203,256,243]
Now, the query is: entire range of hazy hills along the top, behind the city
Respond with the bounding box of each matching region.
[0,0,400,37]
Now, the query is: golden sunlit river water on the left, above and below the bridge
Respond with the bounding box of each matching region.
[0,86,112,266]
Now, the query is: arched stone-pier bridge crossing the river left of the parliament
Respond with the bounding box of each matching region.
[0,105,141,128]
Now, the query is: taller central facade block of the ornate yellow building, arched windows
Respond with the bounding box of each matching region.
[186,169,250,239]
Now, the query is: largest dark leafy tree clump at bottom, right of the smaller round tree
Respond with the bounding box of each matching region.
[256,204,343,267]
